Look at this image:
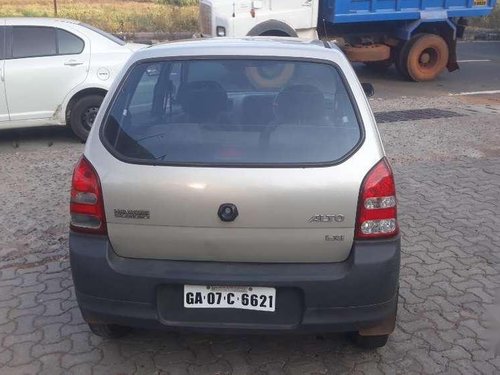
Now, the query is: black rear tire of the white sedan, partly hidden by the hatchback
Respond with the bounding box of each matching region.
[69,95,104,141]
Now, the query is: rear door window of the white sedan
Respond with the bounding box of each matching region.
[12,26,57,58]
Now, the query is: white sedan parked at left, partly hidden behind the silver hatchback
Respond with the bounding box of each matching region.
[0,18,143,140]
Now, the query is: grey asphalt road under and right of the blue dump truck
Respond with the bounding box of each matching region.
[355,41,500,98]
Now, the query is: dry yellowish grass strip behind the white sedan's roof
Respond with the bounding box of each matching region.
[0,0,198,33]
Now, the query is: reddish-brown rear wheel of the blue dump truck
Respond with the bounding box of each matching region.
[396,34,449,81]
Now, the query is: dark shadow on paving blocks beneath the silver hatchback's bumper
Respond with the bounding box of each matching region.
[112,329,364,366]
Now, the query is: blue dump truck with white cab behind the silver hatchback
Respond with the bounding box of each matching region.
[200,0,496,81]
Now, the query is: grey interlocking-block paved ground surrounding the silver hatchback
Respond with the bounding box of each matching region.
[0,98,500,375]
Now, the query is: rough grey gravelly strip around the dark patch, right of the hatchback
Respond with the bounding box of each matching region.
[370,97,500,164]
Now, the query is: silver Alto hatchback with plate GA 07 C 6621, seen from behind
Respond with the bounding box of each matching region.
[70,38,400,348]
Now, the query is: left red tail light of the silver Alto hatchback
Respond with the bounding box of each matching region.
[70,156,107,234]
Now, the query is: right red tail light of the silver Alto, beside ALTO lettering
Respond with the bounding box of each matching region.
[356,158,399,239]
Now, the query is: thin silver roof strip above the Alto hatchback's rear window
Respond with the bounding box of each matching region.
[133,37,345,61]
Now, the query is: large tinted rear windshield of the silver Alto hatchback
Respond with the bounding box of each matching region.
[102,59,362,166]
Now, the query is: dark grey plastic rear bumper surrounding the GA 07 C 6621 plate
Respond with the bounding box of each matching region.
[70,233,400,332]
